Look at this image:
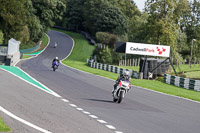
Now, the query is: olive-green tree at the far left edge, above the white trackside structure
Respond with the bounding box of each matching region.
[0,0,27,42]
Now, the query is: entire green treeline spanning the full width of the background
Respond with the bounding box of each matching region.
[0,0,200,63]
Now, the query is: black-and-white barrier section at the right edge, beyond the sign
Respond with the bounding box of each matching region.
[164,74,200,91]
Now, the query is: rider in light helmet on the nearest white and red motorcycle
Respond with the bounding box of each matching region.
[112,70,131,93]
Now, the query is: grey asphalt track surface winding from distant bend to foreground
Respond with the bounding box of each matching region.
[0,31,200,133]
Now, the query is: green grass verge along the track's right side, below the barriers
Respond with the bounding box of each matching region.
[51,30,200,101]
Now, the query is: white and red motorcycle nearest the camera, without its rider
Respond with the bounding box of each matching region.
[113,80,130,103]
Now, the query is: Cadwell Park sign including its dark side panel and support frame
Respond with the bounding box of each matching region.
[115,42,177,78]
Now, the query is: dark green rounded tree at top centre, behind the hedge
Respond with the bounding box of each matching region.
[83,0,128,36]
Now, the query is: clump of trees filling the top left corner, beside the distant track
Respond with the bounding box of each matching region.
[0,0,66,44]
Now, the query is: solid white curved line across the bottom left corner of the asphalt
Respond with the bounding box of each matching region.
[0,106,51,133]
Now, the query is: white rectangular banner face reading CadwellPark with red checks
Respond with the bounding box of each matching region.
[126,42,170,57]
